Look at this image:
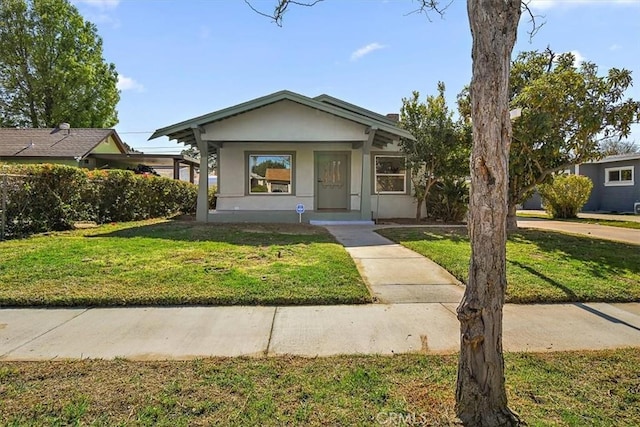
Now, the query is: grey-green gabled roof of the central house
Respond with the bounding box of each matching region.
[149,90,413,145]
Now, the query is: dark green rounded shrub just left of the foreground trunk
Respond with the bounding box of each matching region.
[426,178,469,222]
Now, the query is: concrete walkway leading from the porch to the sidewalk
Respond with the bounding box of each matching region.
[325,225,464,304]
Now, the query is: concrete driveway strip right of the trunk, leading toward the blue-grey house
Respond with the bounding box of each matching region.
[518,217,640,245]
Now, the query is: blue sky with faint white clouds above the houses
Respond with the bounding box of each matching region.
[72,0,640,153]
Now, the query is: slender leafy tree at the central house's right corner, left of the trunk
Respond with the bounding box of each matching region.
[400,82,471,221]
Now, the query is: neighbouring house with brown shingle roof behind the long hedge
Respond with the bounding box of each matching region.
[0,123,199,182]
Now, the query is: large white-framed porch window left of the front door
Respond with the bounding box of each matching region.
[248,154,293,194]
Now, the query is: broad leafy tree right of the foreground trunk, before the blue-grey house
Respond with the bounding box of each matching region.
[508,48,640,228]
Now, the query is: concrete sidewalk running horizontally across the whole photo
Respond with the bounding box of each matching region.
[0,303,640,360]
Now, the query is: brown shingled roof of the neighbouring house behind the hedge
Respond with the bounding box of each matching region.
[0,128,126,158]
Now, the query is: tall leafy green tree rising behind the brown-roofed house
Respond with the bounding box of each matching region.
[0,0,120,128]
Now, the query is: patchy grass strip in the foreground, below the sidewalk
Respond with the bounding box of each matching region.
[0,349,640,426]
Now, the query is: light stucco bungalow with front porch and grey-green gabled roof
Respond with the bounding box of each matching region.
[150,91,415,222]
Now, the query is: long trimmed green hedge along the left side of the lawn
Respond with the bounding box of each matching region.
[0,164,198,237]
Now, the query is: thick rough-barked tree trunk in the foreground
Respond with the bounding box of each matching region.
[456,0,521,426]
